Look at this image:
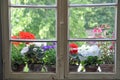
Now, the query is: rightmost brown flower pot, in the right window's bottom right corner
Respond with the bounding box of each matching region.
[100,64,114,72]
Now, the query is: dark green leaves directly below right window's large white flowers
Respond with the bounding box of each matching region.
[82,56,101,66]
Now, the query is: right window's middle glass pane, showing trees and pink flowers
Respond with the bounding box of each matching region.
[69,7,115,38]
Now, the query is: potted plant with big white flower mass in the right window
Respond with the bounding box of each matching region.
[78,42,101,72]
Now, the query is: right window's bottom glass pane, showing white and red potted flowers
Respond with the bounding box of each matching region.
[69,41,115,72]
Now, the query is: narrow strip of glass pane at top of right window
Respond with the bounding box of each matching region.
[69,0,116,4]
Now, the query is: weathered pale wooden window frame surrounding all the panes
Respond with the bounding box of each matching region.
[1,0,120,80]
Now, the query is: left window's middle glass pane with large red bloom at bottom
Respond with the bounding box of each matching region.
[11,8,56,39]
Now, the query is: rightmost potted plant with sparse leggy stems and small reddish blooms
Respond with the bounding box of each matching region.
[100,42,115,72]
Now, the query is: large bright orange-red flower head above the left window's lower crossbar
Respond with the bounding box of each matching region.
[19,31,35,39]
